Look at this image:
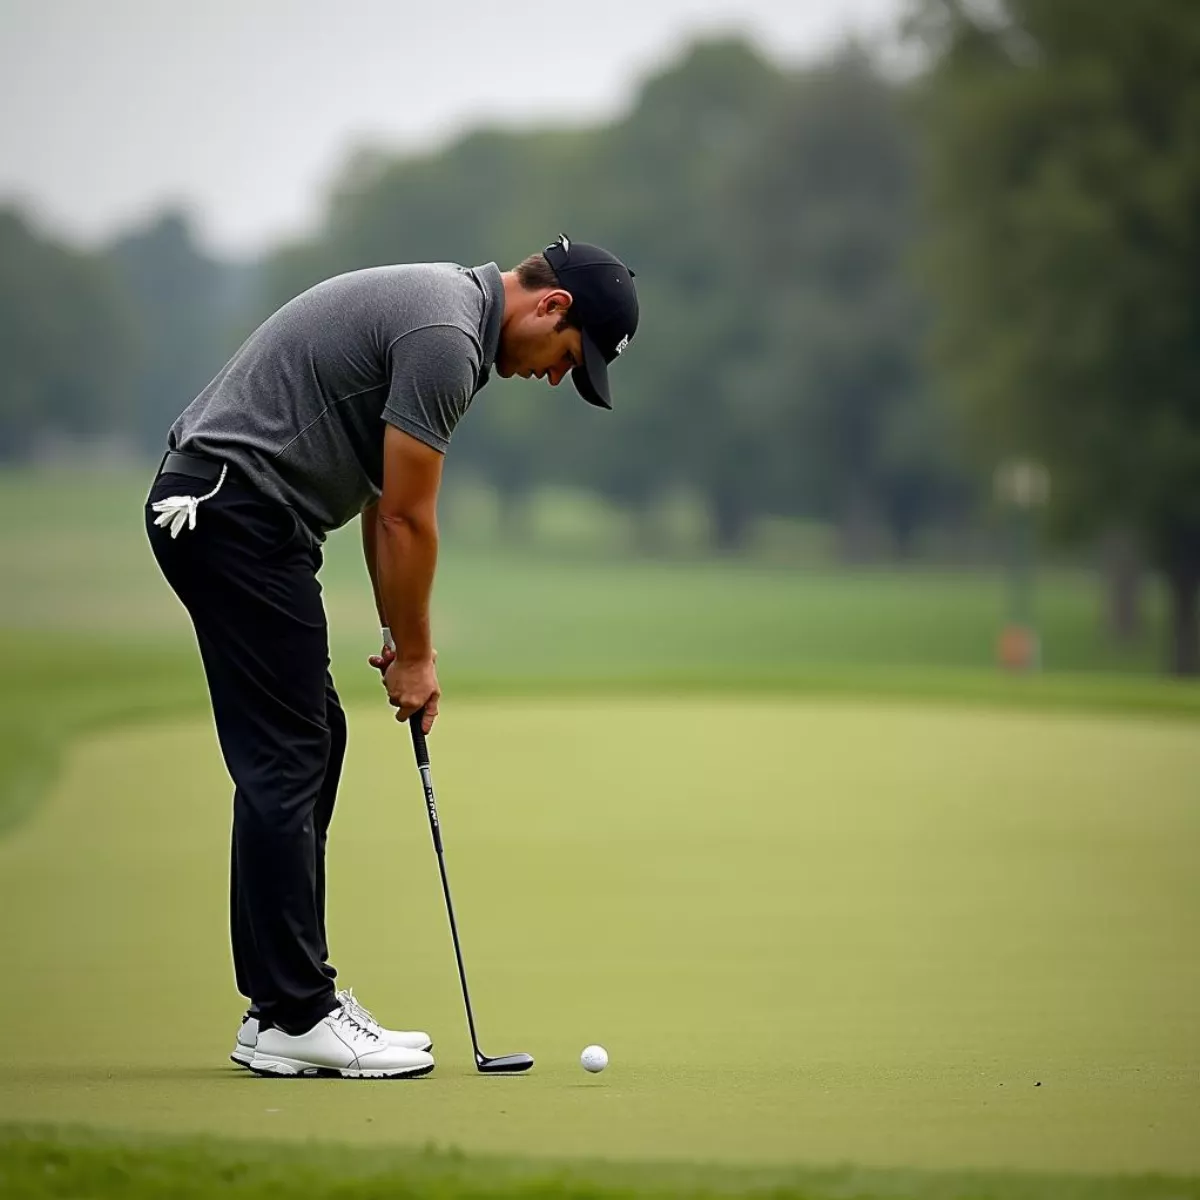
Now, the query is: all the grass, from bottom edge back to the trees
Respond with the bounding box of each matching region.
[0,463,1200,1198]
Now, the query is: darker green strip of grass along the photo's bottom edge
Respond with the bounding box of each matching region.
[0,1126,1200,1200]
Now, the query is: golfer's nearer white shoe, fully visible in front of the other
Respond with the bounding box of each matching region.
[247,1004,433,1079]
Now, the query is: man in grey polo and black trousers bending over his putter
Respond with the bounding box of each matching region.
[146,236,637,1078]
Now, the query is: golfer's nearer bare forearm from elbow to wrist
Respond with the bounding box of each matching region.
[374,514,438,662]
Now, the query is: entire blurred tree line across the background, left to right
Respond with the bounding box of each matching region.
[0,0,1200,672]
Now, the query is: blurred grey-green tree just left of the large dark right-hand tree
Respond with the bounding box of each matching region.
[736,44,964,560]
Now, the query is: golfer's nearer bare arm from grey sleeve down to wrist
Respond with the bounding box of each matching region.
[364,425,443,662]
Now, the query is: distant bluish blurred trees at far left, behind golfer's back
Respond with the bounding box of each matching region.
[0,208,250,463]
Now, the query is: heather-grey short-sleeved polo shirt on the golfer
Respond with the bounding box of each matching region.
[167,263,504,541]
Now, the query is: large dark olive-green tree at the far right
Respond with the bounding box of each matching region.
[916,0,1200,674]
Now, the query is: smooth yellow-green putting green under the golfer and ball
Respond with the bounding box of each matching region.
[0,700,1200,1172]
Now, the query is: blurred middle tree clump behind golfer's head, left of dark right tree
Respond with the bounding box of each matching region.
[260,38,959,551]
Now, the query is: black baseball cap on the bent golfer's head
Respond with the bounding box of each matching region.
[542,234,637,408]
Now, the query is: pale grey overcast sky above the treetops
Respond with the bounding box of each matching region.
[0,0,900,253]
